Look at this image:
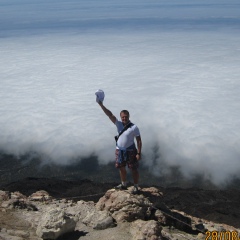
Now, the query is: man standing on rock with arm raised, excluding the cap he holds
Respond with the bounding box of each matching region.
[98,101,142,194]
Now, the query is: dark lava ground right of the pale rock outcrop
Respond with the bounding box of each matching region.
[163,188,240,228]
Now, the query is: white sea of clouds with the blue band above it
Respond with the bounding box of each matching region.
[0,0,240,186]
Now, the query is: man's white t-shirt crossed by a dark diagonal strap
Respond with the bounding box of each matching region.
[115,119,140,148]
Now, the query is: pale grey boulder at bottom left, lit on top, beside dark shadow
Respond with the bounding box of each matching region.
[36,208,76,239]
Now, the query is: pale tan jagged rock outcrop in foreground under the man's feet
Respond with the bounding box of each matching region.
[0,187,240,240]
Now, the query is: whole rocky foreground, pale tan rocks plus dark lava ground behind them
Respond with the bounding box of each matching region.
[0,178,240,240]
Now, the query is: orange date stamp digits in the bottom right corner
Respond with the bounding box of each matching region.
[205,231,240,240]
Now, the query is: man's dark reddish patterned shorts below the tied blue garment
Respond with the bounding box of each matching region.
[115,149,139,169]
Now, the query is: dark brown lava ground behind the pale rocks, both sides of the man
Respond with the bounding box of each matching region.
[1,178,240,228]
